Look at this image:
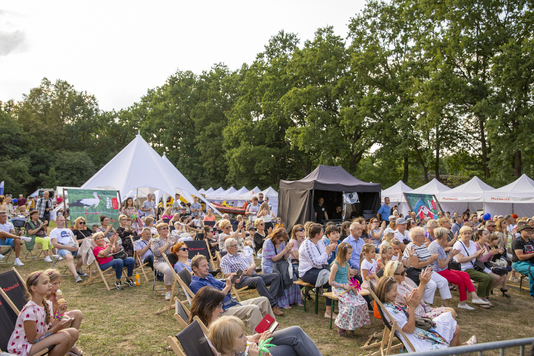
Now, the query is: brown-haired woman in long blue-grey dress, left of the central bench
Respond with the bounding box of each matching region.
[261,228,302,309]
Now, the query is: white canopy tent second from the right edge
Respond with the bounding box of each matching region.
[437,176,495,215]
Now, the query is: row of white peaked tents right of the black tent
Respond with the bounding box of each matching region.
[381,174,534,217]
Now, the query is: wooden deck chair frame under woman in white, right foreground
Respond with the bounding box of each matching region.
[361,283,415,356]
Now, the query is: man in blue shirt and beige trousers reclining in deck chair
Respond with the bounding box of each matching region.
[189,255,275,335]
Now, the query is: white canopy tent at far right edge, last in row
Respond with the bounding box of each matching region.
[484,174,534,217]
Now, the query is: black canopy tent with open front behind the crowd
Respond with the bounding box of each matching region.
[278,165,382,228]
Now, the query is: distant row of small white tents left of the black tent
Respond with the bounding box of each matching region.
[199,186,278,215]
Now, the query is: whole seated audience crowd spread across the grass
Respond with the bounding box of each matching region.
[0,194,534,355]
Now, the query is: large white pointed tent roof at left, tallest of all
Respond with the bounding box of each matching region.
[82,134,174,196]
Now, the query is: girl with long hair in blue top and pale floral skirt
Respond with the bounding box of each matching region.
[328,242,370,336]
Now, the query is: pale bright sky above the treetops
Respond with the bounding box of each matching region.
[0,0,365,110]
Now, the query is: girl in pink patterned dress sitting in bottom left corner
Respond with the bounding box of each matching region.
[7,271,78,356]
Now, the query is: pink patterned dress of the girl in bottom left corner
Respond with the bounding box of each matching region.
[7,300,53,356]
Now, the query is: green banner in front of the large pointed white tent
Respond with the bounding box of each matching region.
[67,188,120,229]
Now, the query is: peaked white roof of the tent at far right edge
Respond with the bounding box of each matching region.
[484,174,534,203]
